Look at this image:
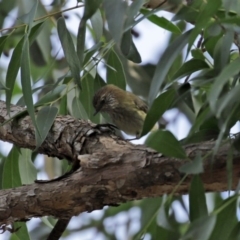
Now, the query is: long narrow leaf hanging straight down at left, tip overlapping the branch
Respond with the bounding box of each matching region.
[21,34,41,148]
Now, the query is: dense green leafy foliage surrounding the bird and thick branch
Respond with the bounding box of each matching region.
[0,0,240,240]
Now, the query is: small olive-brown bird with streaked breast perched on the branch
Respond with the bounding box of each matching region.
[93,84,157,138]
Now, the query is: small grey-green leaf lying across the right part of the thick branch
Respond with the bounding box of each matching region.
[179,154,204,174]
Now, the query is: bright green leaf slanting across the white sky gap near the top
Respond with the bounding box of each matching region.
[140,8,182,34]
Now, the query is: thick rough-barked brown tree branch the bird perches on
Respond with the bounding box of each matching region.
[0,102,240,225]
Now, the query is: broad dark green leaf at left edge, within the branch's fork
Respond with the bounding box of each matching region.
[2,146,22,189]
